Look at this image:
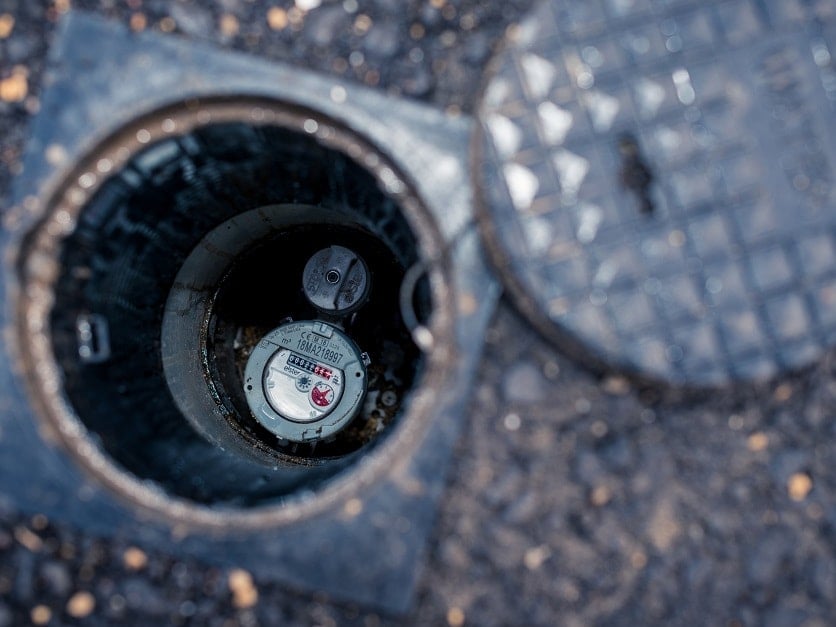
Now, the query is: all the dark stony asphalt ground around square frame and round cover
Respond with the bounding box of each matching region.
[0,0,836,626]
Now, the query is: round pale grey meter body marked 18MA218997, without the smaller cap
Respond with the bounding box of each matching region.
[244,321,367,442]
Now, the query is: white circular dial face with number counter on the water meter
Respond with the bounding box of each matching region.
[264,348,345,422]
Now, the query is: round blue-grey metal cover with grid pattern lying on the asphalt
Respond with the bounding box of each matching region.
[475,0,836,385]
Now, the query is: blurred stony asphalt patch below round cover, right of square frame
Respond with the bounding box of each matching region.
[418,306,836,625]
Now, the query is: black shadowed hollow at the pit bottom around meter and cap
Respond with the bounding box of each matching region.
[208,224,419,464]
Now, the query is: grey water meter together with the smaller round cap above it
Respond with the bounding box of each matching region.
[244,246,370,442]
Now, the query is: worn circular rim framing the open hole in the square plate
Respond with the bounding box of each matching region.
[7,93,458,530]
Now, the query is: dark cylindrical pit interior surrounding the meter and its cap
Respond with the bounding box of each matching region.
[44,115,434,508]
